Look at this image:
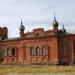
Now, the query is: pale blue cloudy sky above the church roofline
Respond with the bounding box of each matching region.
[0,0,75,38]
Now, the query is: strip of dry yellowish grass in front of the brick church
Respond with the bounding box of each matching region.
[0,65,75,75]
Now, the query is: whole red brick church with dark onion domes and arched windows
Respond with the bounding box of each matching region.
[0,16,75,64]
